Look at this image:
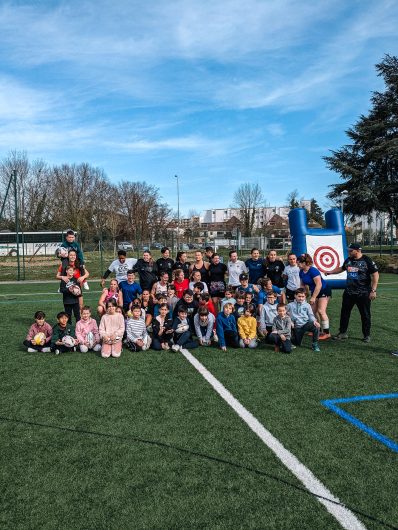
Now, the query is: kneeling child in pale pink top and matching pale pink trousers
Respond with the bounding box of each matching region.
[99,300,124,359]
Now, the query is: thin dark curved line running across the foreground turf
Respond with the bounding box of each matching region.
[0,416,398,530]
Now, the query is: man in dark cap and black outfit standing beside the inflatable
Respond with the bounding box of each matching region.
[327,243,379,342]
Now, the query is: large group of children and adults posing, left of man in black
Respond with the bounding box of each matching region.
[24,230,330,358]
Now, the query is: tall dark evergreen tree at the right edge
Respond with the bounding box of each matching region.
[324,55,398,227]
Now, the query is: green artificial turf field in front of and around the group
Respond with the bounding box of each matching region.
[0,275,398,529]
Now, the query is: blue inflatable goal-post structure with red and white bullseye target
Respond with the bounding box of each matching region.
[289,208,347,289]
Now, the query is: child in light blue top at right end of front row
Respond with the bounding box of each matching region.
[287,287,321,351]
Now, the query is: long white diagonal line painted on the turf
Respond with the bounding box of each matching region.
[180,349,366,530]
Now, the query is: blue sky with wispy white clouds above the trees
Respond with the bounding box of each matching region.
[0,0,398,214]
